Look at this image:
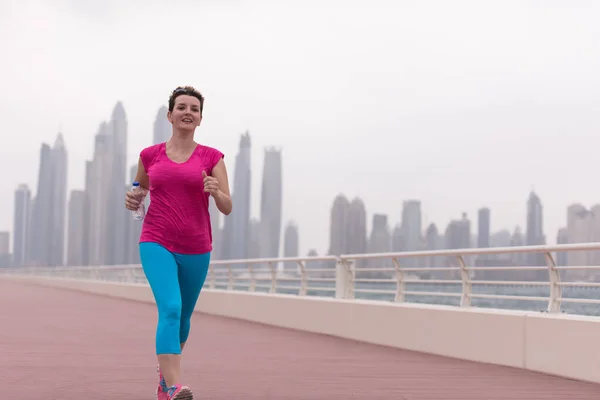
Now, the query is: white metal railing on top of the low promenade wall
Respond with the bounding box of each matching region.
[0,243,600,315]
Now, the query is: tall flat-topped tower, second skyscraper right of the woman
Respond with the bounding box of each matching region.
[260,148,283,258]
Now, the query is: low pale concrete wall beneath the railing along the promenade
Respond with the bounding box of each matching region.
[8,278,600,383]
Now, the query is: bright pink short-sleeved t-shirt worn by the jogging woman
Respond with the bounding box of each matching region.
[140,143,224,254]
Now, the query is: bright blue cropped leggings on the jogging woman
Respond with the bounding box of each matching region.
[139,242,210,354]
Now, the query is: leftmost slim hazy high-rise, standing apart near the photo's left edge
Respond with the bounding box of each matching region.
[13,184,31,267]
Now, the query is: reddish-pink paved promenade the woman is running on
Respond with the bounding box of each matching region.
[0,278,600,400]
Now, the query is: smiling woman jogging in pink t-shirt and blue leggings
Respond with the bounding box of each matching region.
[125,86,232,400]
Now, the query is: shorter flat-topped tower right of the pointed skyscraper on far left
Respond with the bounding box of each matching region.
[67,190,86,266]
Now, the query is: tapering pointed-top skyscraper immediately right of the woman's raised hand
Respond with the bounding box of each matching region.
[222,132,251,260]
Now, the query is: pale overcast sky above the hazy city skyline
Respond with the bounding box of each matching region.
[0,0,600,254]
